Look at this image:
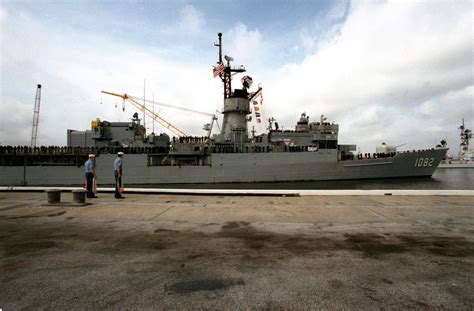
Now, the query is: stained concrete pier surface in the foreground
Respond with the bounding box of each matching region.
[0,190,474,310]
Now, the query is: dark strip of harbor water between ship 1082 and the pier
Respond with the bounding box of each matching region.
[144,168,474,190]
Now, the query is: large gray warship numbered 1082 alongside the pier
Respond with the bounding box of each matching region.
[0,33,447,185]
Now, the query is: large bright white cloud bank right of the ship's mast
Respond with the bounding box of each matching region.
[264,1,474,152]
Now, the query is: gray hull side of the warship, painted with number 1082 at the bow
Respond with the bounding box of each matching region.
[0,149,445,186]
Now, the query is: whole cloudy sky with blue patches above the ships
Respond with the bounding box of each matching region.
[0,0,474,153]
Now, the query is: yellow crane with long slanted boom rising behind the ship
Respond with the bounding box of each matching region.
[102,91,217,138]
